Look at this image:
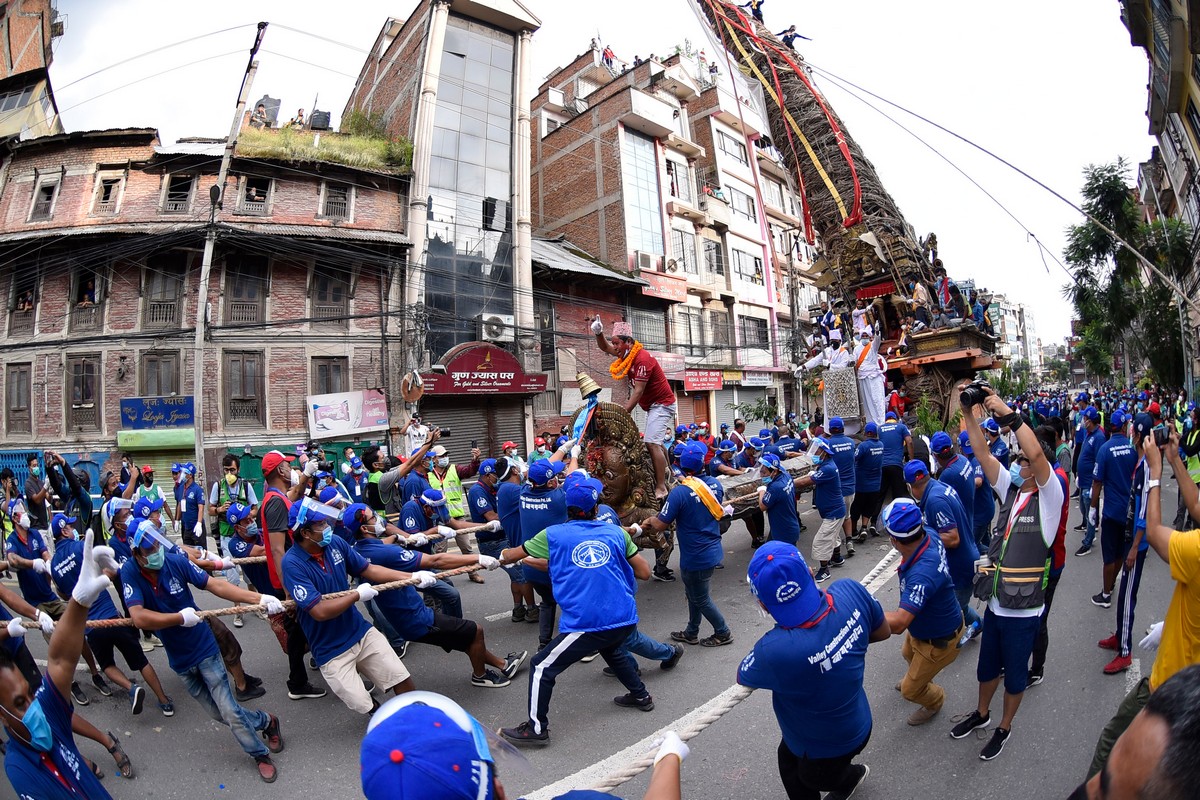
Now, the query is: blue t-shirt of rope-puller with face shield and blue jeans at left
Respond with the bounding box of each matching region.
[121,552,221,673]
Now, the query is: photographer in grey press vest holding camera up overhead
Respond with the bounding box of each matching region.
[950,381,1066,760]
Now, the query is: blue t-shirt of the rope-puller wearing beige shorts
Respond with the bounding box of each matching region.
[281,536,372,666]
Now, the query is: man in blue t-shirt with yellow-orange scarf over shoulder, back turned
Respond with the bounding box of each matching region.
[638,446,729,648]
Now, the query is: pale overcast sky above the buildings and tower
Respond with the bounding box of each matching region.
[52,0,1153,344]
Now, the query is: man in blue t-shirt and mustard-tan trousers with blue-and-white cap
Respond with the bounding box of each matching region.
[883,503,962,726]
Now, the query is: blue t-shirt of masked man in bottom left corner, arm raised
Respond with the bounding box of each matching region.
[4,676,112,800]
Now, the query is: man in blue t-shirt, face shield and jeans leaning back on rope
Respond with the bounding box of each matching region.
[121,519,283,783]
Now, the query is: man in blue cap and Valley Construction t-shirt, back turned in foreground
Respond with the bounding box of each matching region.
[738,542,890,798]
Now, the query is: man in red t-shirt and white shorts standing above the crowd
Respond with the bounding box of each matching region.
[592,317,677,500]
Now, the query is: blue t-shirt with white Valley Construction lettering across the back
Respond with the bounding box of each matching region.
[738,578,884,758]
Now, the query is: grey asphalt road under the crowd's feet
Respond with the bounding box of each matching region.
[0,481,1175,800]
